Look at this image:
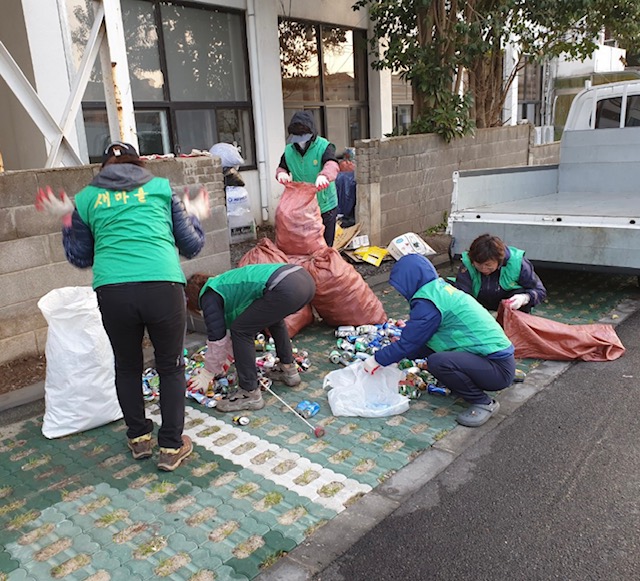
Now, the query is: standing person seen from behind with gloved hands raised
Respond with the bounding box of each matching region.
[36,142,210,471]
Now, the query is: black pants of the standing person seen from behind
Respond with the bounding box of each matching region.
[96,282,186,448]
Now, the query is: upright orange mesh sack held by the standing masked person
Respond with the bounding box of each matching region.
[275,182,327,254]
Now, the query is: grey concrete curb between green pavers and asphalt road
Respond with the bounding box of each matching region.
[255,294,640,581]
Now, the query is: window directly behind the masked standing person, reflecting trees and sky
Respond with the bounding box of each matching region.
[279,20,369,155]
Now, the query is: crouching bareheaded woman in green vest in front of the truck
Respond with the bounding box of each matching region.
[455,234,547,313]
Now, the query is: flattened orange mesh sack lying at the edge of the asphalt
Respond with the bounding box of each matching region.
[498,305,625,361]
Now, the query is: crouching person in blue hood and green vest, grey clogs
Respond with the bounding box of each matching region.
[364,254,516,427]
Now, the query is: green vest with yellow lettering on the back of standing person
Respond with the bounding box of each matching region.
[74,178,186,288]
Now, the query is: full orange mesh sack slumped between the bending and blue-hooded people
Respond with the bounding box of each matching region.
[302,247,387,327]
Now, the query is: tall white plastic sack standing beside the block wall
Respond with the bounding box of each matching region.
[38,286,122,438]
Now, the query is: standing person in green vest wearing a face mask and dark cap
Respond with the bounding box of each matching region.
[276,111,340,246]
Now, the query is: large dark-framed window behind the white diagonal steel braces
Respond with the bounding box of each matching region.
[66,0,255,166]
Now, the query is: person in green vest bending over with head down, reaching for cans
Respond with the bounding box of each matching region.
[186,263,316,412]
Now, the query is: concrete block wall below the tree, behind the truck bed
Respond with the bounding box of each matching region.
[356,125,532,245]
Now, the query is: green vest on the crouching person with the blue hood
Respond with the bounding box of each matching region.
[411,278,511,356]
